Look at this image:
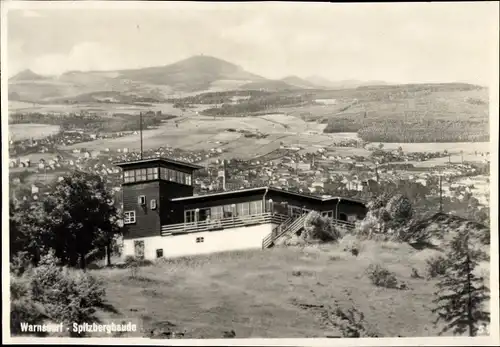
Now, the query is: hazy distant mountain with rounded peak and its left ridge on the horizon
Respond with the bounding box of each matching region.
[5,56,267,103]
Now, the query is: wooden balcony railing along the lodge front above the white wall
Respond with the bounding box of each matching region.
[161,212,288,236]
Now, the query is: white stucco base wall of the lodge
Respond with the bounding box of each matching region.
[122,224,273,260]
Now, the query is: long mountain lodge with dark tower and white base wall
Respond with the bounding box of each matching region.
[116,158,366,260]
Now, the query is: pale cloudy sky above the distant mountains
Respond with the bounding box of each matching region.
[7,1,498,85]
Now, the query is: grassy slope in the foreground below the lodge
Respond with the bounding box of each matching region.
[95,241,486,338]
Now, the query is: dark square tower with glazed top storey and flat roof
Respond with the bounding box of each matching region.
[116,158,202,239]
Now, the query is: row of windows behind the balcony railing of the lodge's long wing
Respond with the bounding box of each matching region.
[184,200,264,223]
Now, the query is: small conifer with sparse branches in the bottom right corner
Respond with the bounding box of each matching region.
[433,231,490,336]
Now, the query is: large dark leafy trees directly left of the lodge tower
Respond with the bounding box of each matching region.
[10,172,120,268]
